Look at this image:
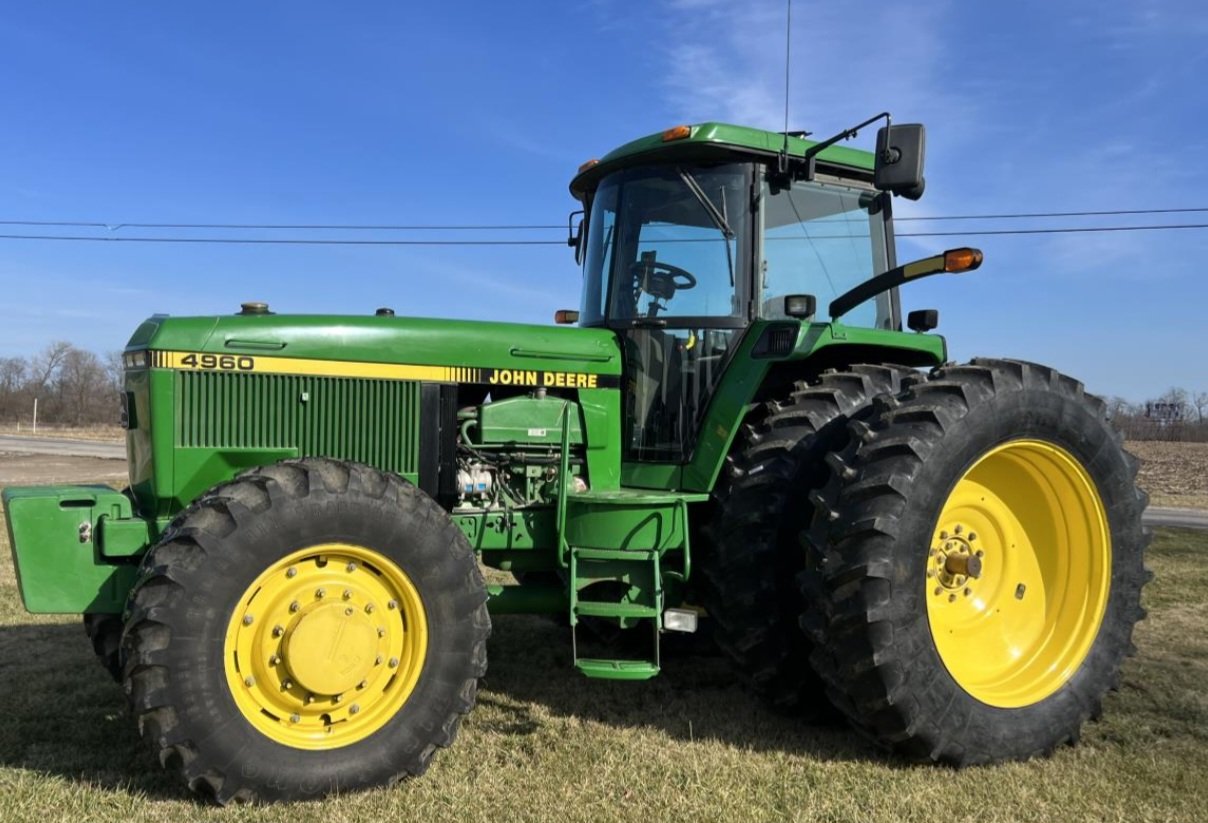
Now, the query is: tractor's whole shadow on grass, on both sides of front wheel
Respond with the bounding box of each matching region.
[0,615,894,801]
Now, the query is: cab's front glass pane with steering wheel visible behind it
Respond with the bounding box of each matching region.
[580,163,751,326]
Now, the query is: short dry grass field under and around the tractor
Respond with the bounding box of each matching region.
[0,485,1208,823]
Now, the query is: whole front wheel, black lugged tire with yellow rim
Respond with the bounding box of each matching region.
[123,458,490,804]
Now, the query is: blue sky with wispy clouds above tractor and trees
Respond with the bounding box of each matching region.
[0,0,1208,400]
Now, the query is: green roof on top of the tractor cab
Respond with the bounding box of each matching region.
[570,122,873,199]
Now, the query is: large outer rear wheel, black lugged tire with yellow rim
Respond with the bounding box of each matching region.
[803,360,1148,765]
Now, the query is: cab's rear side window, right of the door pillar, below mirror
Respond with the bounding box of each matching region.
[759,175,896,329]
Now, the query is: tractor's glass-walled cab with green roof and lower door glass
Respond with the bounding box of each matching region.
[571,124,900,463]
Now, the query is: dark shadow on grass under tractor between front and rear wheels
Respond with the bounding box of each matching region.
[474,615,889,766]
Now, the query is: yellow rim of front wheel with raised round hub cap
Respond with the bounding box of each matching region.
[223,543,428,749]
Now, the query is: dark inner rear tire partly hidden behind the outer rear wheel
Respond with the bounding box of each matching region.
[699,366,917,718]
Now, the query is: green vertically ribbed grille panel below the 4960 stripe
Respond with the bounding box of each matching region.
[176,371,419,475]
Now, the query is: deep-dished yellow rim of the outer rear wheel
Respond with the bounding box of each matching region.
[925,440,1111,708]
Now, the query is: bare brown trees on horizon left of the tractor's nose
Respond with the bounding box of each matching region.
[0,341,122,429]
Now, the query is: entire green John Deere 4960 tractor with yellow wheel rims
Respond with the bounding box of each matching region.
[4,118,1146,802]
